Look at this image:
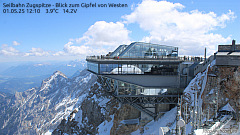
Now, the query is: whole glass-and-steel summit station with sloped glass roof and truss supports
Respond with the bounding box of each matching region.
[86,42,208,119]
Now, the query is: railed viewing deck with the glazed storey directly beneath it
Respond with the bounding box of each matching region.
[86,55,204,76]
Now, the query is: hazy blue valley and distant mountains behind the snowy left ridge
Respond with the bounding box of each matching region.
[0,60,86,93]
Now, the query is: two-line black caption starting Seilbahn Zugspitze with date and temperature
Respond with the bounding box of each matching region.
[2,2,128,14]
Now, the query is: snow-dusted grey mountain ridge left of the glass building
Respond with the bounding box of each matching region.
[0,70,96,135]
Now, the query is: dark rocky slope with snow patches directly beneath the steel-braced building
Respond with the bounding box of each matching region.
[53,79,139,135]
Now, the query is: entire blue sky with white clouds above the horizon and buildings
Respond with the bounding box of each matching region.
[0,0,240,62]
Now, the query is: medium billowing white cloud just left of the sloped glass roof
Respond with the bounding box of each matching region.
[64,21,130,57]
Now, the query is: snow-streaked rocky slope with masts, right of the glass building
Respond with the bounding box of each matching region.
[181,61,240,133]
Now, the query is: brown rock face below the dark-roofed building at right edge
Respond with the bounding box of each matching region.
[202,66,240,121]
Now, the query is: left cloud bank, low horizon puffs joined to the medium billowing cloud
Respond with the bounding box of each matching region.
[0,21,130,58]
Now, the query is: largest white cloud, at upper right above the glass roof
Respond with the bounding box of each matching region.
[122,0,235,55]
